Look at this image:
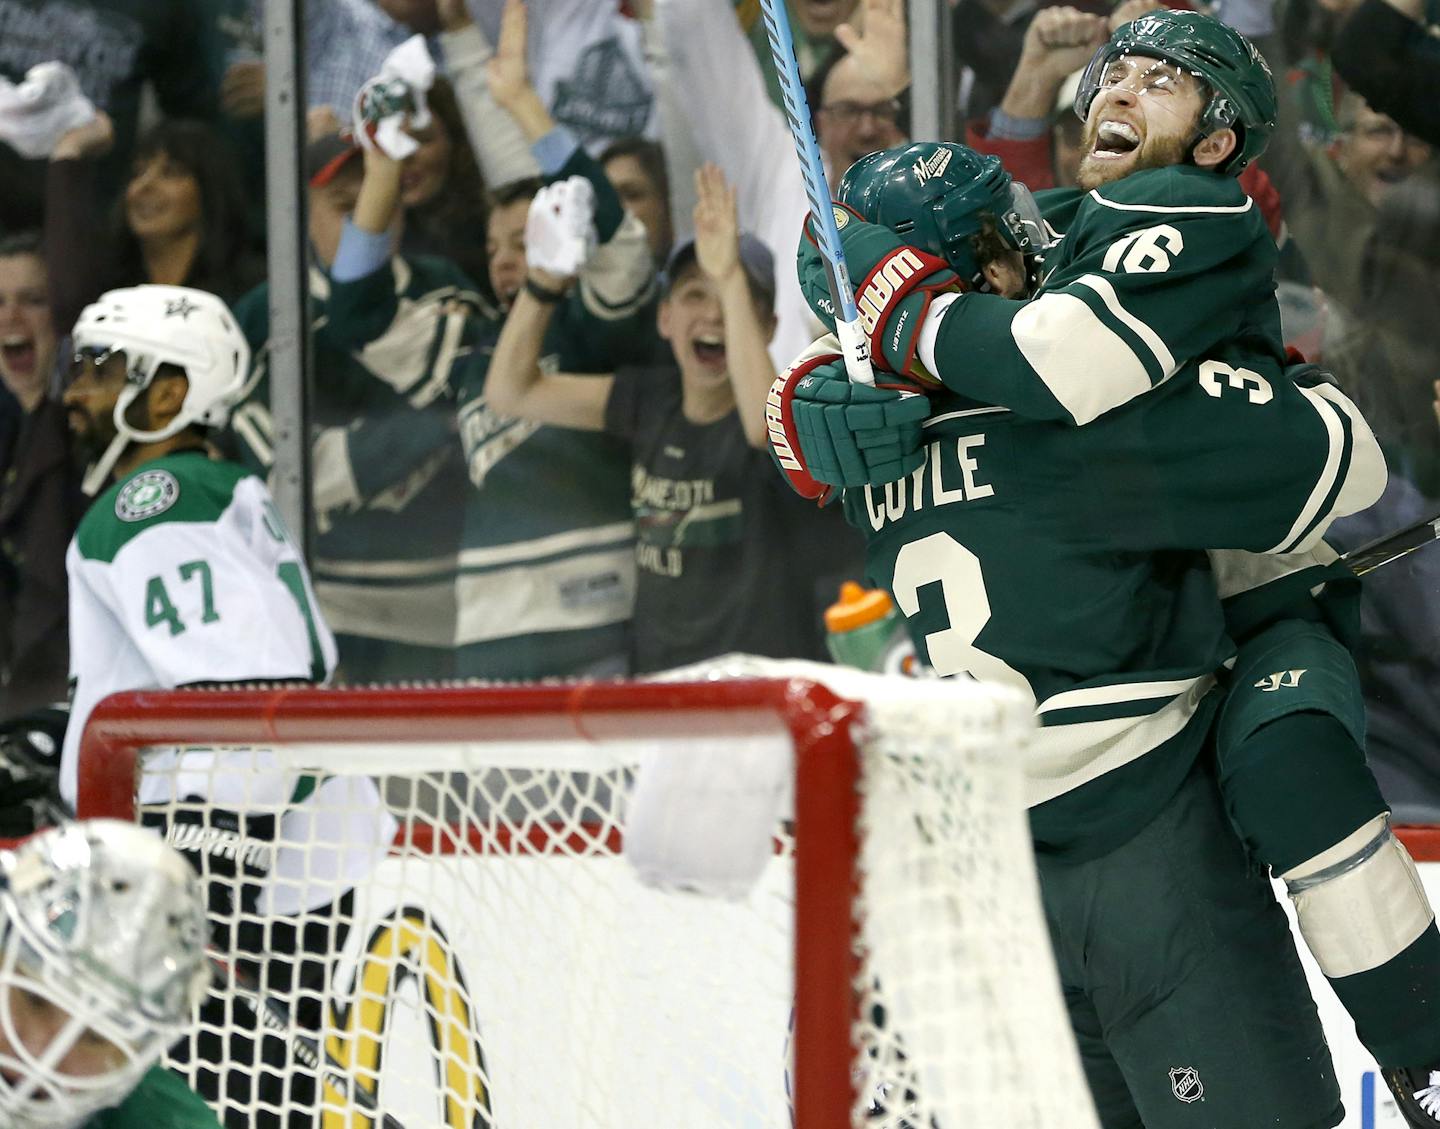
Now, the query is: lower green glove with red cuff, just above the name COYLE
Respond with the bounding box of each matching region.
[765,353,930,504]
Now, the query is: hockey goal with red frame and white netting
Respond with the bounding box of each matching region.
[79,664,1089,1129]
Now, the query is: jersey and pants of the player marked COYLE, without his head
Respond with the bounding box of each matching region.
[783,306,1384,1129]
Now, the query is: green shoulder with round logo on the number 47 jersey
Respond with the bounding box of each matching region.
[75,451,251,563]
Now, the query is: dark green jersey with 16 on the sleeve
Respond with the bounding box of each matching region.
[920,167,1283,423]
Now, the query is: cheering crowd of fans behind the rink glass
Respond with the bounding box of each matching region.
[0,0,1440,818]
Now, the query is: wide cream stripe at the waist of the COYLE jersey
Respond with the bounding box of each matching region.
[1024,674,1215,808]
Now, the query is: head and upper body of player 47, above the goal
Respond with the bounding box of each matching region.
[60,287,336,806]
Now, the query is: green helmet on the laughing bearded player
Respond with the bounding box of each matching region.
[1076,9,1276,176]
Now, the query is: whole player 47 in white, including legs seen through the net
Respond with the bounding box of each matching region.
[60,285,395,1126]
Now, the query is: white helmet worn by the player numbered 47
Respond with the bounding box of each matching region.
[72,285,251,494]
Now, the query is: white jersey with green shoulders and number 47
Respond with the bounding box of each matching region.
[60,451,396,914]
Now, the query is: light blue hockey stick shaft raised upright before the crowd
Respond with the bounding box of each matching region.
[760,0,876,384]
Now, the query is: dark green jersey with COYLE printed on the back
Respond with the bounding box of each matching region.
[845,347,1385,855]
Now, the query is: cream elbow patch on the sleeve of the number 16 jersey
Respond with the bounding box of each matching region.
[1009,288,1151,425]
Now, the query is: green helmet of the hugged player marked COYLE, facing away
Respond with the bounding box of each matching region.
[837,141,1045,285]
